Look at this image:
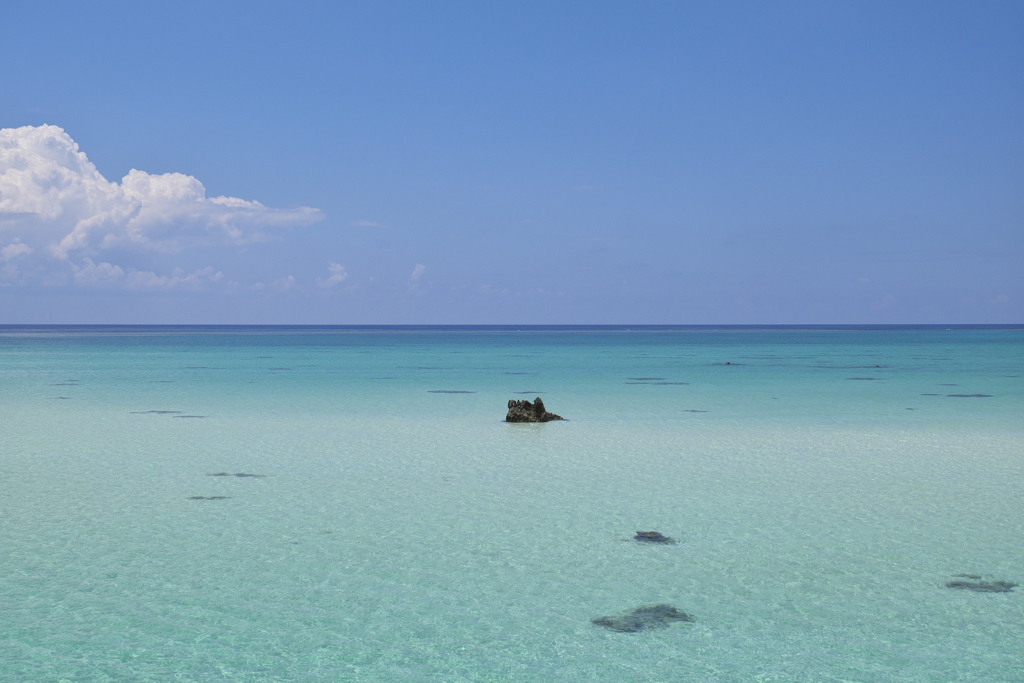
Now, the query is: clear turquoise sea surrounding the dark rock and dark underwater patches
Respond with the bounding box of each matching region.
[0,328,1024,682]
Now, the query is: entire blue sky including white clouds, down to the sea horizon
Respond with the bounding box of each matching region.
[0,0,1024,325]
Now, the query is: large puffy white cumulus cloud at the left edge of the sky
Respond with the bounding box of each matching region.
[0,126,323,262]
